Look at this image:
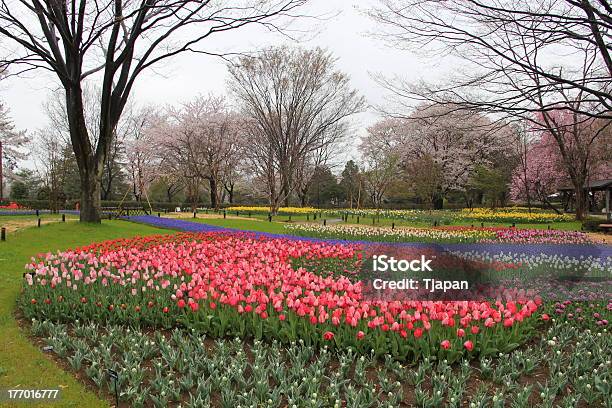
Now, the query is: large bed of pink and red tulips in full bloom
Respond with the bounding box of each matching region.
[20,233,540,362]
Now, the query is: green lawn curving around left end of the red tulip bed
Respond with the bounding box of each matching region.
[0,220,173,407]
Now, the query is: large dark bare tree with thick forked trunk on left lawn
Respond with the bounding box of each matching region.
[0,0,306,222]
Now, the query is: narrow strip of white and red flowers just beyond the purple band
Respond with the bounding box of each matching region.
[285,224,596,245]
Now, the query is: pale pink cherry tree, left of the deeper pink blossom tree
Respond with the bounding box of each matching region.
[361,104,511,208]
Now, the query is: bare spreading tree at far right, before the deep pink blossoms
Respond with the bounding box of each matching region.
[370,0,612,219]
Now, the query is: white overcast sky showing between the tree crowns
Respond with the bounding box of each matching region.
[0,0,450,166]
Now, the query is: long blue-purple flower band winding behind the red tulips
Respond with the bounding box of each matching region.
[126,215,612,261]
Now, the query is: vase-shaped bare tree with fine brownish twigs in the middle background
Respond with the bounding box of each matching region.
[228,47,364,212]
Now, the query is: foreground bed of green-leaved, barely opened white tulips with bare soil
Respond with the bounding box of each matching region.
[29,302,612,408]
